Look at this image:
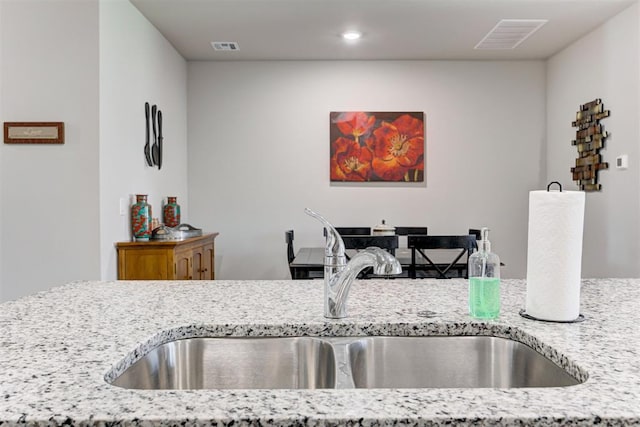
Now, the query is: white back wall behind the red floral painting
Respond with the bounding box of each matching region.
[188,61,546,279]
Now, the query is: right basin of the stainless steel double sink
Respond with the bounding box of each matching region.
[347,336,579,388]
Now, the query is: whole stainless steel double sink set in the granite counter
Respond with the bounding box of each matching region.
[111,336,580,389]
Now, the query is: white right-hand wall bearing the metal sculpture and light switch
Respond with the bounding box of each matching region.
[546,4,640,277]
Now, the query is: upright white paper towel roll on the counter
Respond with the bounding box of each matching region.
[525,191,585,321]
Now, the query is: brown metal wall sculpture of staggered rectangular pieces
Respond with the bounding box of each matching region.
[571,98,609,191]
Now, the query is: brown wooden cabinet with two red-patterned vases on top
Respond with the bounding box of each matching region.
[116,233,218,280]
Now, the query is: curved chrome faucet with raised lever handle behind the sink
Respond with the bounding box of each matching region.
[304,208,402,319]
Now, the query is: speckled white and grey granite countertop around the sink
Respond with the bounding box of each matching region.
[0,279,640,427]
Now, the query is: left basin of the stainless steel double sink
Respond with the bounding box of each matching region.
[112,337,336,389]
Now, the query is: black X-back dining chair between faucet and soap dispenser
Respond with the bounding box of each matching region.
[407,234,477,279]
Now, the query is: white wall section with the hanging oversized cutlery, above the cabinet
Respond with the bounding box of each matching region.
[100,0,189,279]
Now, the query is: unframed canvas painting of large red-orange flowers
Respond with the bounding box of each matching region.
[329,111,425,182]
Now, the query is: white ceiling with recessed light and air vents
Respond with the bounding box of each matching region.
[130,0,637,61]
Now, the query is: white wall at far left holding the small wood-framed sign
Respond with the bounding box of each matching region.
[0,0,100,300]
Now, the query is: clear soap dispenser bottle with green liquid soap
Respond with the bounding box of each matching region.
[469,227,500,319]
